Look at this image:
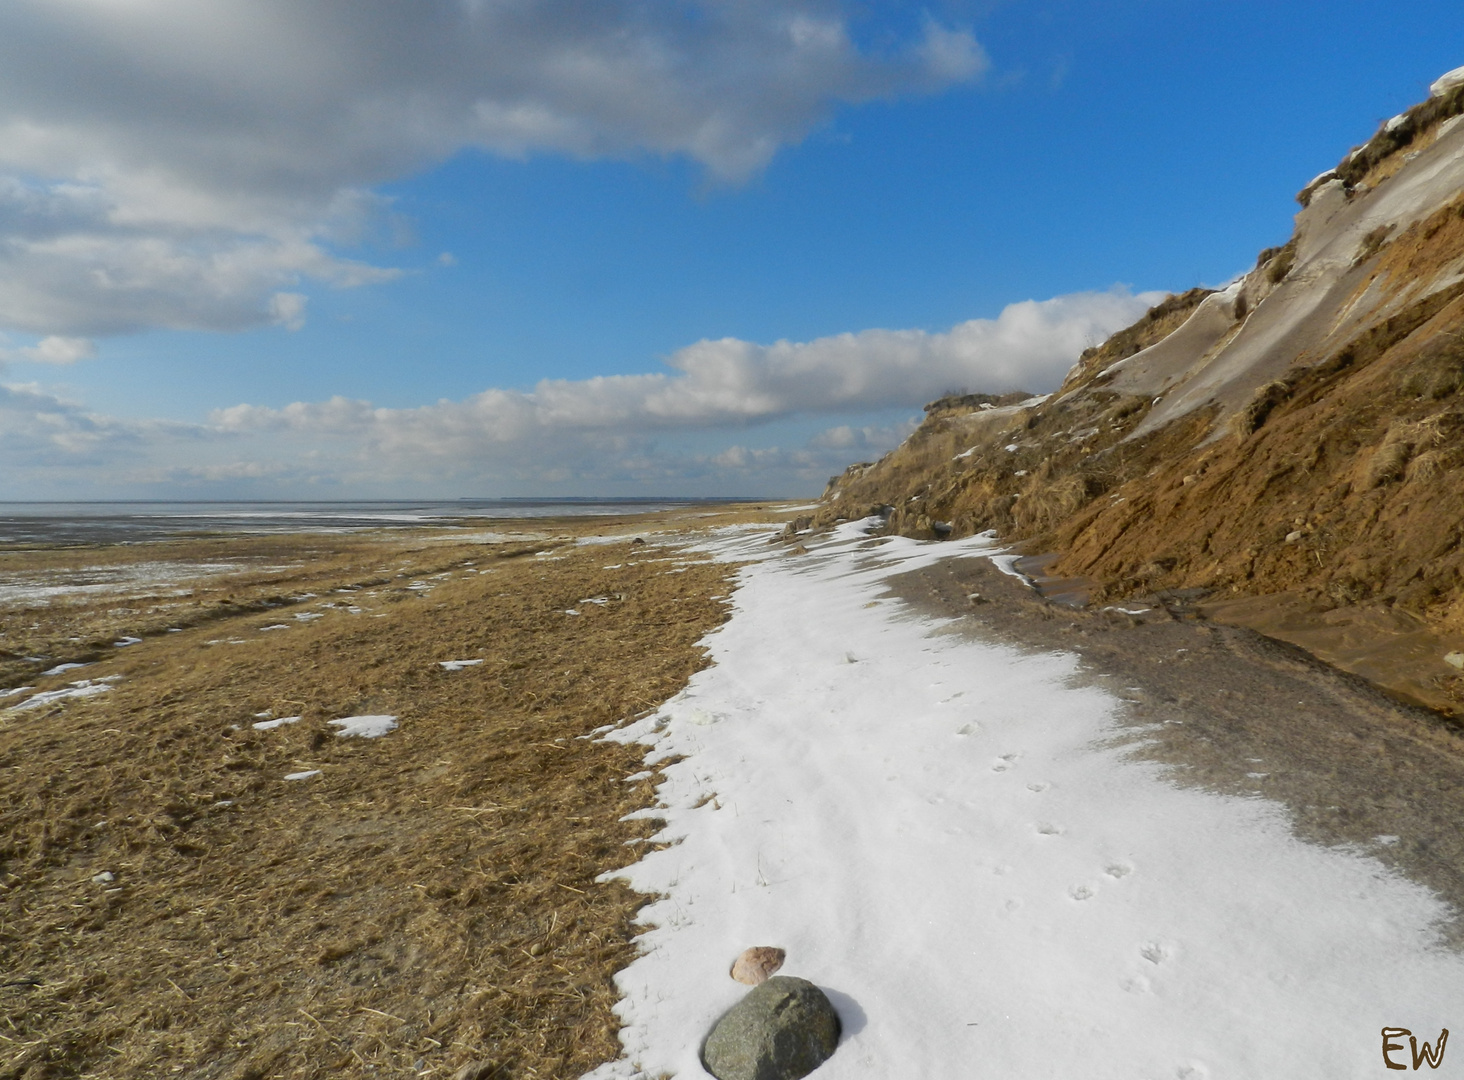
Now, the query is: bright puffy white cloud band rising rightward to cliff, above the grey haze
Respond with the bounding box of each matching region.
[214,288,1164,441]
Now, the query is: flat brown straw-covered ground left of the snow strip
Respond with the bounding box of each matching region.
[0,509,796,1080]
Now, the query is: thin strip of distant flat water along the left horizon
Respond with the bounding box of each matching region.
[0,499,716,546]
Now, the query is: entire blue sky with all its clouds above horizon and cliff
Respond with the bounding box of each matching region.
[0,0,1464,498]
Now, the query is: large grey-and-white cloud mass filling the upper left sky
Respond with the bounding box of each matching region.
[0,0,987,335]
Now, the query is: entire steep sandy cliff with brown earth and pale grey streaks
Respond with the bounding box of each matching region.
[820,79,1464,713]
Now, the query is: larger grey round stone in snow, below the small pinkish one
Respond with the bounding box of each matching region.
[701,975,839,1080]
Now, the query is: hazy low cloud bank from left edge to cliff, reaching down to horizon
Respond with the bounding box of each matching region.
[0,288,1164,498]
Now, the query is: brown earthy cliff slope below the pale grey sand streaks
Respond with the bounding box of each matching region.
[815,196,1464,717]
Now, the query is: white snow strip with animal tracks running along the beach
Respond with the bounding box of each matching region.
[591,525,1464,1080]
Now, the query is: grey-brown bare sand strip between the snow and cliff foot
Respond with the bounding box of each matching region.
[893,559,1464,948]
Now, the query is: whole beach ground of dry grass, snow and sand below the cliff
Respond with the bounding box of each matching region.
[0,505,1464,1080]
